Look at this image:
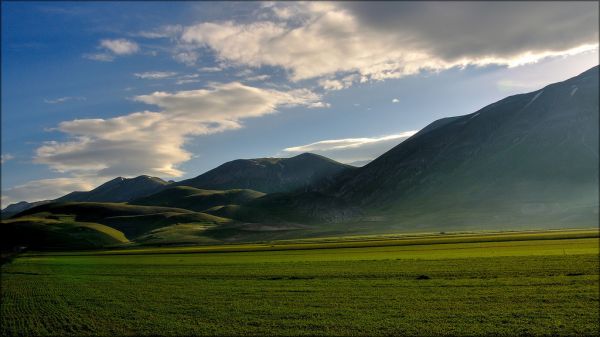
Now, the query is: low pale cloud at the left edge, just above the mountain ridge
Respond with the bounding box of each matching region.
[2,177,102,203]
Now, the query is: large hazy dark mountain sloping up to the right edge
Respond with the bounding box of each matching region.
[229,67,599,230]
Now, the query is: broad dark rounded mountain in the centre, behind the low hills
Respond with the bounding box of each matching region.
[173,153,355,193]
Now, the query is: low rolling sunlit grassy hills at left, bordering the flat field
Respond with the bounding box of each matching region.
[5,202,232,248]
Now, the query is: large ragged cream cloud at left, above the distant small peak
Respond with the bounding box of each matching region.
[34,82,322,177]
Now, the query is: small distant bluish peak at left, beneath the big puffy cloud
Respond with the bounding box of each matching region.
[54,175,169,202]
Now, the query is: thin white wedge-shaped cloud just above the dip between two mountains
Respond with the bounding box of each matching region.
[283,130,418,163]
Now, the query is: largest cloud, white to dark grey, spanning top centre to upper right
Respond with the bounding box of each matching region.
[179,2,598,83]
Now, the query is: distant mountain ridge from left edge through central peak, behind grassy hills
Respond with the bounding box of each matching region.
[2,153,354,218]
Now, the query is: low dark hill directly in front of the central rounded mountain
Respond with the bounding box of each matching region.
[129,186,265,211]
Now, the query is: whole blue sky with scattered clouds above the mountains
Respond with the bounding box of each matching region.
[1,1,598,208]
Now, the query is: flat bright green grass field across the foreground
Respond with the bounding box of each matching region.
[0,230,600,336]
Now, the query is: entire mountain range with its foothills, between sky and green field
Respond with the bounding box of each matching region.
[2,66,599,248]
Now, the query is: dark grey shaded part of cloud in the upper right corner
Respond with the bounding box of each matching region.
[339,1,598,61]
